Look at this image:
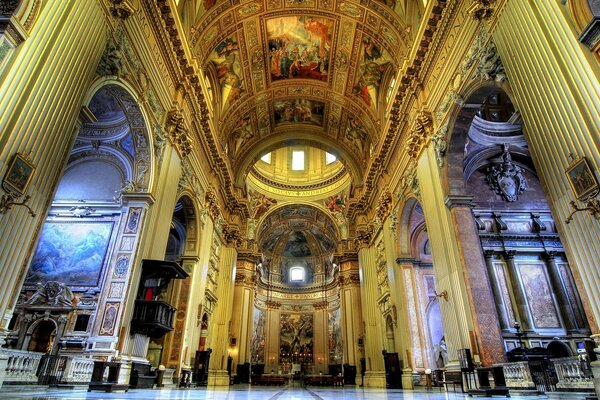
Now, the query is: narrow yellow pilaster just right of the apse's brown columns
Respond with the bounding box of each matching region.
[358,243,386,387]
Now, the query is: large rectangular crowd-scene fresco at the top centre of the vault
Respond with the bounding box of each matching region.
[267,16,333,81]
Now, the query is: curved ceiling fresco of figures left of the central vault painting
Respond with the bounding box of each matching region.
[209,35,245,109]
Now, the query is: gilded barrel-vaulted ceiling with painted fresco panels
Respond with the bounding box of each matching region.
[178,0,424,190]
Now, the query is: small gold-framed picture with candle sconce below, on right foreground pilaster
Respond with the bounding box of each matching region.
[565,154,600,224]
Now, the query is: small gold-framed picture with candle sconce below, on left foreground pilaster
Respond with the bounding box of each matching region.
[0,153,35,217]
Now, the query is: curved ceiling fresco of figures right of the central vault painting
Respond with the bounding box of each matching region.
[353,36,392,110]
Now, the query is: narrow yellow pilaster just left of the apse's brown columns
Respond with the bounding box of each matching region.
[208,243,237,386]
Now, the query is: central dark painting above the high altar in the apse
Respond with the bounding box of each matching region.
[279,314,313,360]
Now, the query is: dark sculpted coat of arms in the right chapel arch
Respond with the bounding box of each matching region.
[486,143,527,202]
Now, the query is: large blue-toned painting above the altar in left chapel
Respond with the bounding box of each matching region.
[25,221,113,286]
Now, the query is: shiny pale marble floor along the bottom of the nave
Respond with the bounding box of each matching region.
[0,385,546,400]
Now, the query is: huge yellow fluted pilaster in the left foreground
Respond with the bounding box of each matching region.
[0,0,106,323]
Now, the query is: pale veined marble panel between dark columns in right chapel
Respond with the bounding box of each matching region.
[519,264,560,328]
